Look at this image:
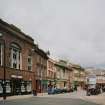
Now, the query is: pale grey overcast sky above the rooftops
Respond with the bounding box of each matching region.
[0,0,105,68]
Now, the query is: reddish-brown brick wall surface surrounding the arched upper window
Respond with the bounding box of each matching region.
[0,28,36,89]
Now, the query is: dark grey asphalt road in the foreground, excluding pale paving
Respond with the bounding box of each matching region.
[0,97,98,105]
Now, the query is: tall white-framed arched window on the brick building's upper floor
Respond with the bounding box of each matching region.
[11,43,21,69]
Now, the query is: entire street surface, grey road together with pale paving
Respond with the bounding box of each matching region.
[0,91,105,105]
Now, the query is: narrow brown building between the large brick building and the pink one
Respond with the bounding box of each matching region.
[35,48,48,93]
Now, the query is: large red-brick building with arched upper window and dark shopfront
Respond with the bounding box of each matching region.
[0,20,35,96]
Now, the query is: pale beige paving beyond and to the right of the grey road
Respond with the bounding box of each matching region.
[38,90,105,105]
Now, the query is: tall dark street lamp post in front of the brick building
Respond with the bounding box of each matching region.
[0,33,6,101]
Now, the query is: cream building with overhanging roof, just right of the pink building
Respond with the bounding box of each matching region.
[55,60,72,89]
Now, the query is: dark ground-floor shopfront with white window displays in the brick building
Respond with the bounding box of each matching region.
[0,78,32,96]
